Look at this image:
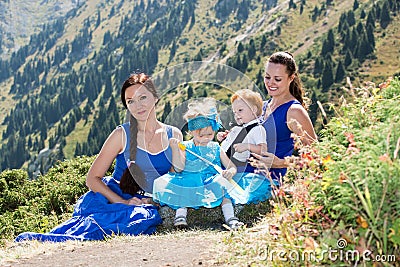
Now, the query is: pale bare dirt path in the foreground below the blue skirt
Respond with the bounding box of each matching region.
[0,230,227,267]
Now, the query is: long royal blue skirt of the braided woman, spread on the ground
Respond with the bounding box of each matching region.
[15,177,162,242]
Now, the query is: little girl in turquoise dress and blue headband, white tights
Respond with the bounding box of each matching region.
[153,98,243,230]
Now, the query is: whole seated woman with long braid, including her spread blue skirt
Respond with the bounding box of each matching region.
[16,73,182,242]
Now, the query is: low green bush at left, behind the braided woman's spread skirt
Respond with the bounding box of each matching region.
[0,157,98,242]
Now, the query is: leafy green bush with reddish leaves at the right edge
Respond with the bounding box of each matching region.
[312,79,400,253]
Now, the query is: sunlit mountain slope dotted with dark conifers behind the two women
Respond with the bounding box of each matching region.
[0,0,400,175]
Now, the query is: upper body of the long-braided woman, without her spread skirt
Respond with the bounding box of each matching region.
[86,73,183,205]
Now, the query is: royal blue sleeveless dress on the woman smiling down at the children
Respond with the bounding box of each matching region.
[263,99,301,184]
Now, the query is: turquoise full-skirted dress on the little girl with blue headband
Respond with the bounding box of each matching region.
[153,140,224,209]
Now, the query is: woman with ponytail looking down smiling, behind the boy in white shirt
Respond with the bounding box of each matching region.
[250,52,317,184]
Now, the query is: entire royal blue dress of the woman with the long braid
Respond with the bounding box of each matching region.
[15,123,172,242]
